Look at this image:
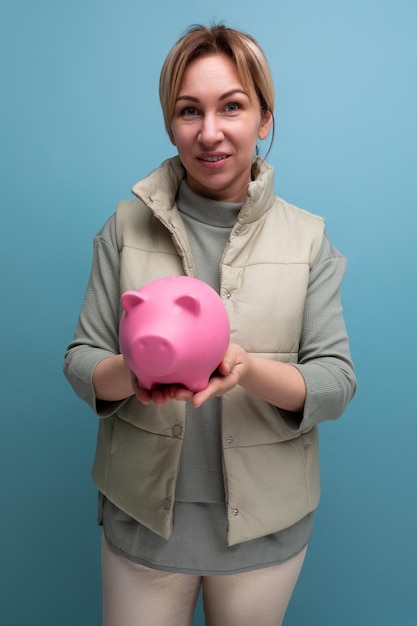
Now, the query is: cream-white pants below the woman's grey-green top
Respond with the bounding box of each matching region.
[102,539,307,626]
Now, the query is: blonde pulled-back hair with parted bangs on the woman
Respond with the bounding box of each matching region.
[159,24,274,135]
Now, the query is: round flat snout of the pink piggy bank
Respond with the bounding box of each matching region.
[132,335,177,376]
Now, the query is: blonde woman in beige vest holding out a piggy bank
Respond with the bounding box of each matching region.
[64,25,355,626]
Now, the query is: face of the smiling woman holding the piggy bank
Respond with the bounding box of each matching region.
[171,54,272,202]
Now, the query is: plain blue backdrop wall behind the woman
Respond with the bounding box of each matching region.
[0,0,417,626]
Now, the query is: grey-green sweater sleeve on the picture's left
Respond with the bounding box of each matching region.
[64,215,124,417]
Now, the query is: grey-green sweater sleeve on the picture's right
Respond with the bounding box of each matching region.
[282,235,356,431]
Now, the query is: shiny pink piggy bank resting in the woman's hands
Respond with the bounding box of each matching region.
[119,276,230,392]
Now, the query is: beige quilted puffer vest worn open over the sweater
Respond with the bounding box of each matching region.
[93,158,324,545]
